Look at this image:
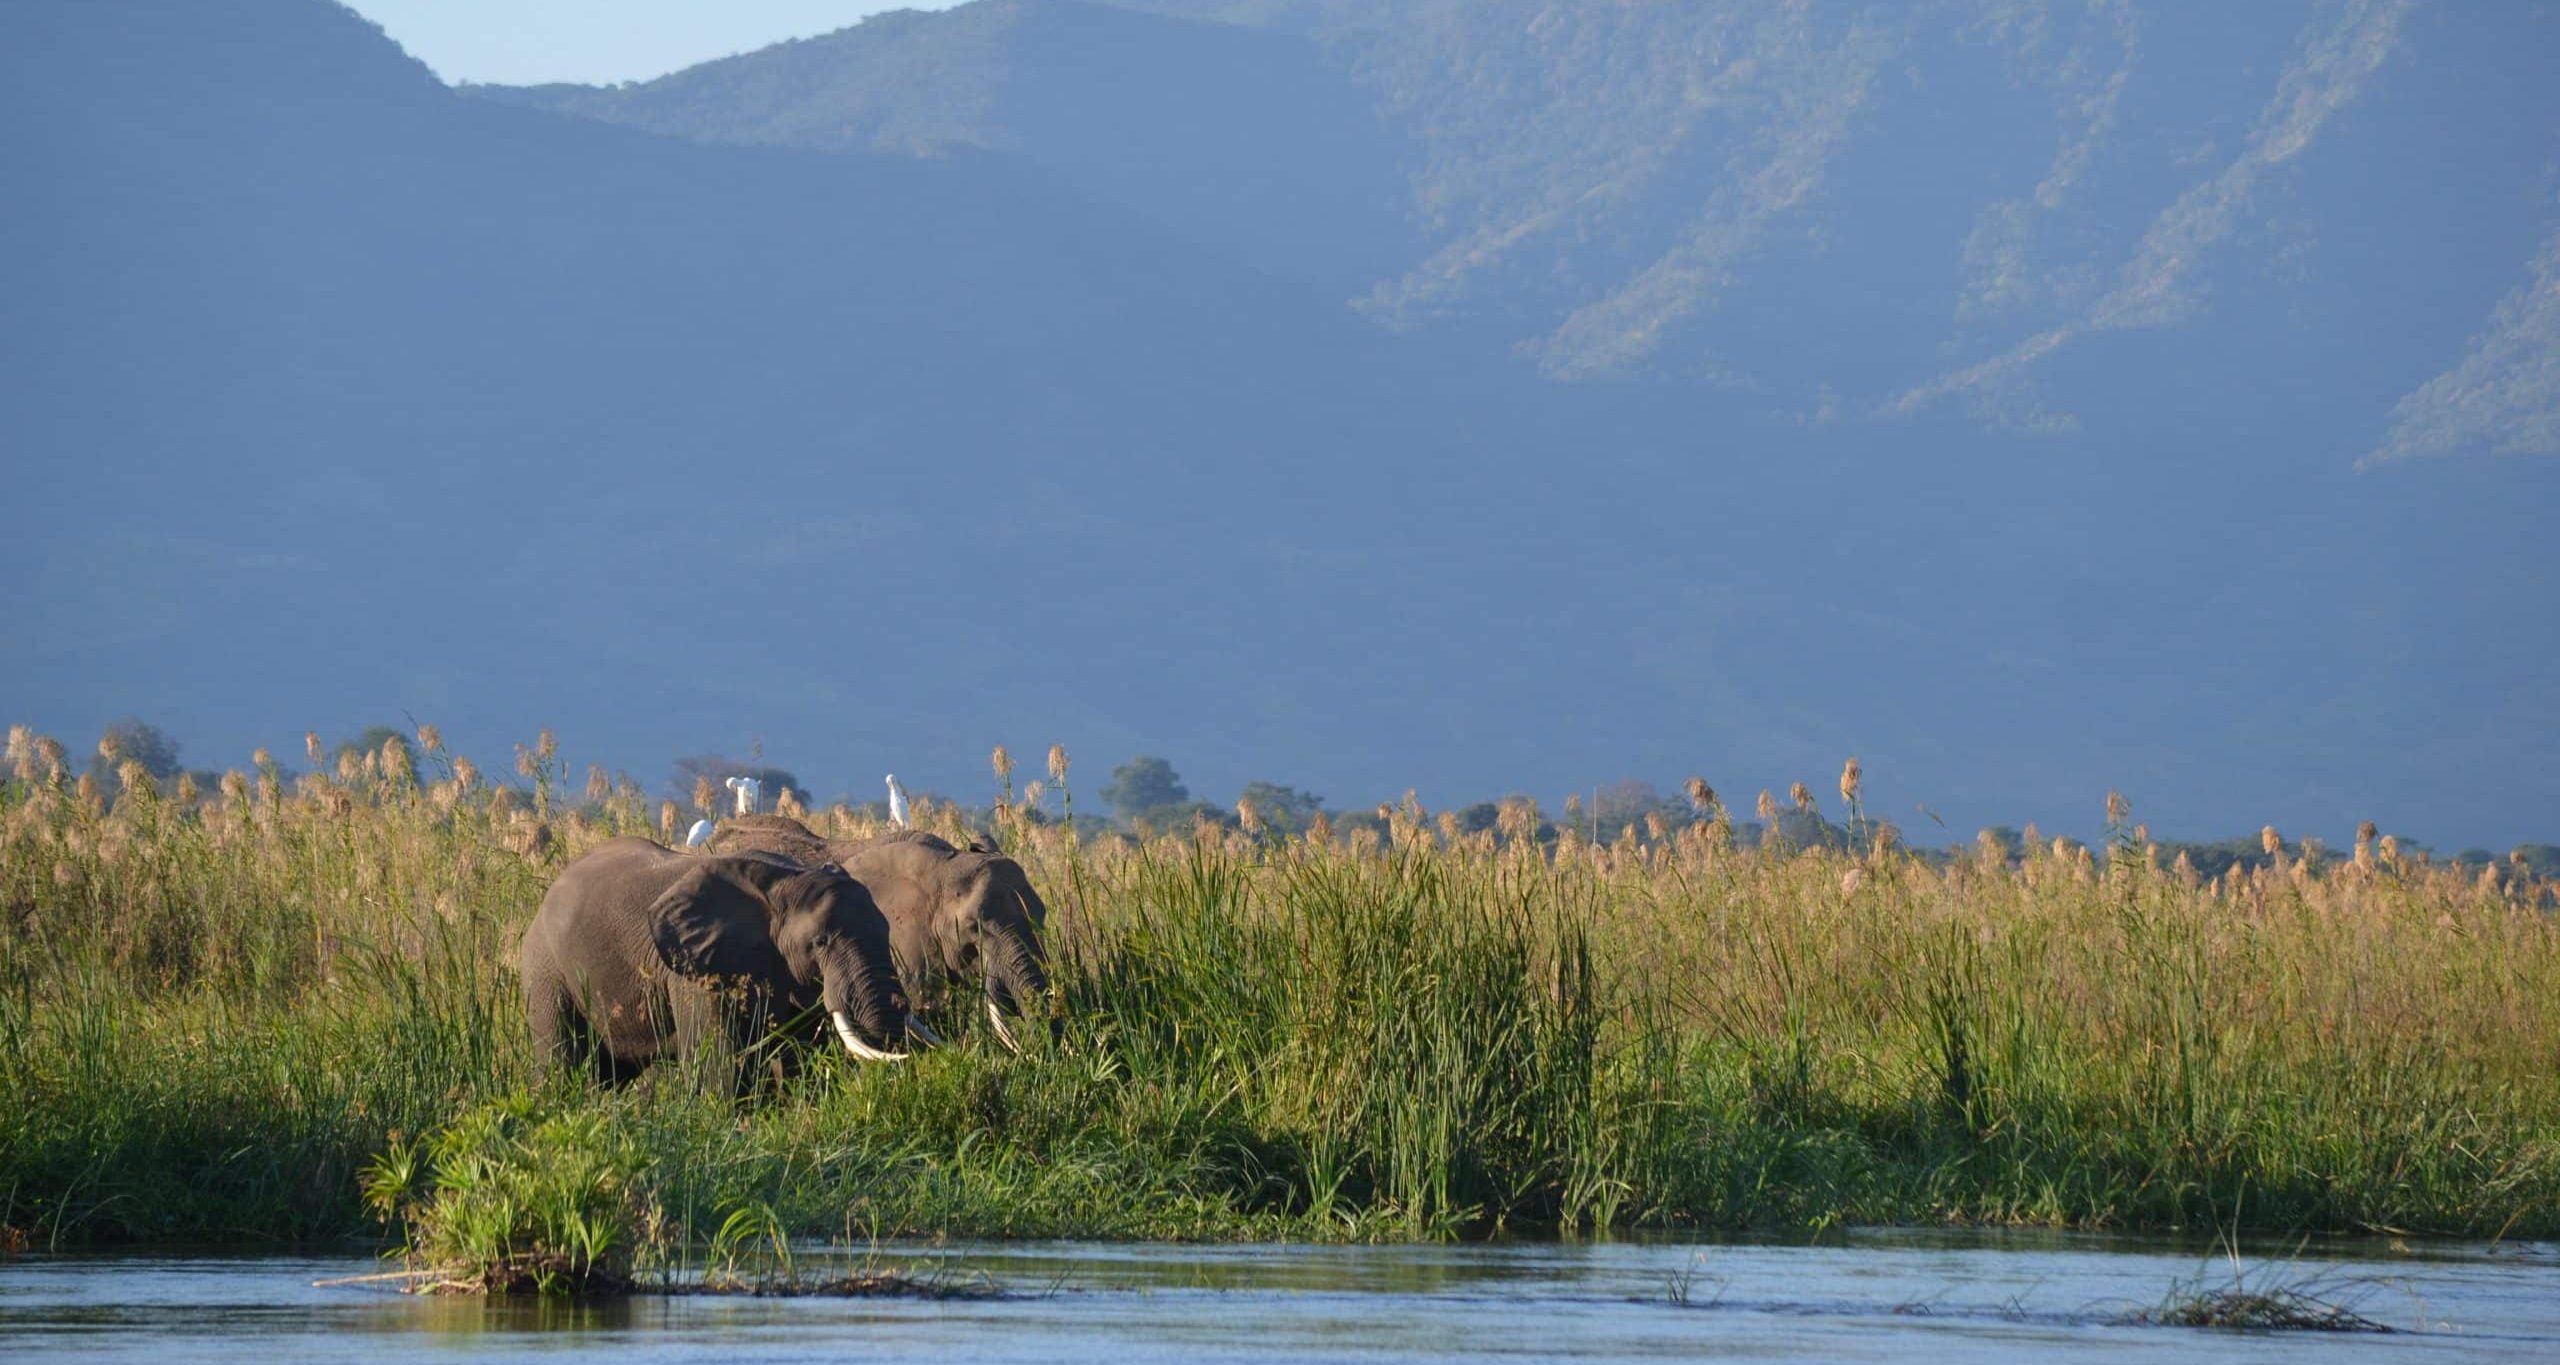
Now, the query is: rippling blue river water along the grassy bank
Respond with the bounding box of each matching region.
[0,1232,2560,1365]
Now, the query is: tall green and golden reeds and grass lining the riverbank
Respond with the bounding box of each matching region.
[0,722,2560,1255]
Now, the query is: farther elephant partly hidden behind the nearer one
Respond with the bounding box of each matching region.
[712,814,1050,1053]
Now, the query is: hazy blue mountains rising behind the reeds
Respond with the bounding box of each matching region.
[0,0,2560,848]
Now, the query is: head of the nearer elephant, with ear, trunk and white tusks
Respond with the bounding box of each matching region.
[648,853,924,1060]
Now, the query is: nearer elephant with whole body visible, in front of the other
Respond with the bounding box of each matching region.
[517,837,927,1083]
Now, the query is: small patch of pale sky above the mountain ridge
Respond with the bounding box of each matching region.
[348,0,960,85]
